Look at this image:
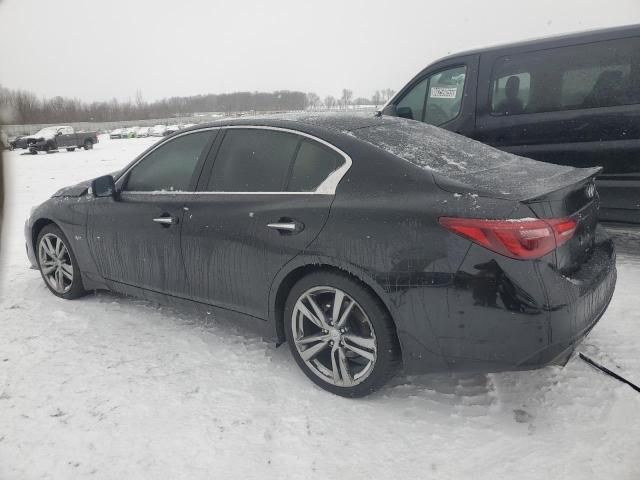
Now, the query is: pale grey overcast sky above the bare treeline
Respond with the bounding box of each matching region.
[0,0,640,100]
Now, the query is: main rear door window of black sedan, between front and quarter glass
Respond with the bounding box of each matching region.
[207,128,299,192]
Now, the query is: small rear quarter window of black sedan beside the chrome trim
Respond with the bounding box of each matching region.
[287,140,344,192]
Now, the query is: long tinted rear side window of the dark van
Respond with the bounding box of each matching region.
[491,38,640,115]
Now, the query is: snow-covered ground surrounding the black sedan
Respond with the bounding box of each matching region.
[0,137,640,480]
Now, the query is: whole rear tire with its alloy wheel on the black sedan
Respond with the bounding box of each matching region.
[283,271,401,398]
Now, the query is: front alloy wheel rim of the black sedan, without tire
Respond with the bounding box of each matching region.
[38,233,73,294]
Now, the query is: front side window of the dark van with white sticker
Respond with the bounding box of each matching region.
[396,65,467,125]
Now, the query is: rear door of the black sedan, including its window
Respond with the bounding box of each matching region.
[182,127,351,318]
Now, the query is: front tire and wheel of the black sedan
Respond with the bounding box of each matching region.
[35,223,87,300]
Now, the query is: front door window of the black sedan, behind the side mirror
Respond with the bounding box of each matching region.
[124,131,212,192]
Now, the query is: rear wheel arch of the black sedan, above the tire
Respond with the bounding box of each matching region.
[269,258,402,349]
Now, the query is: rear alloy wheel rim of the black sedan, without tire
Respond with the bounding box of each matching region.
[291,286,377,387]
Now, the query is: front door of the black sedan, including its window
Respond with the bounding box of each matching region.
[87,129,216,296]
